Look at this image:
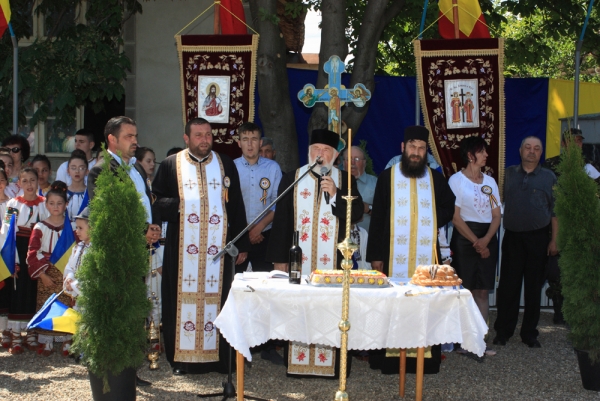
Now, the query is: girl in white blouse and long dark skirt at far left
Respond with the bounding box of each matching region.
[2,167,48,354]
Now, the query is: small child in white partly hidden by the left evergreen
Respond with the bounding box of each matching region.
[63,207,92,310]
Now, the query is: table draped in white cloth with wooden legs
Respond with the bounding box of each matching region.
[214,273,488,400]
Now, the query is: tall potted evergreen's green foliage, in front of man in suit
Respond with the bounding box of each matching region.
[73,147,151,392]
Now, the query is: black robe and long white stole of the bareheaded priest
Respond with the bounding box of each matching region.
[152,150,250,373]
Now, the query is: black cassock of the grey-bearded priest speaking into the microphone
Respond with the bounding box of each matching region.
[267,170,364,268]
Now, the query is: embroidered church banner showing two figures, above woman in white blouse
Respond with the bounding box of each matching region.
[413,38,505,193]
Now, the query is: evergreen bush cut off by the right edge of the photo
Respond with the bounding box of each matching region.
[555,135,600,363]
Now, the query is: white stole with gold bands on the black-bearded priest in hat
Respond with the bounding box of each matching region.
[389,163,437,278]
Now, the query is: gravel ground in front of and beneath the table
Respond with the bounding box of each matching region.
[0,312,600,401]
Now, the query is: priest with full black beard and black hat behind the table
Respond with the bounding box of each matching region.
[367,126,456,374]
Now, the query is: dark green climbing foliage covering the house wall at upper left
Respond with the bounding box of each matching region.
[0,0,141,136]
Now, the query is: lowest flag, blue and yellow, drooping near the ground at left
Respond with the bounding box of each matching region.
[27,292,80,334]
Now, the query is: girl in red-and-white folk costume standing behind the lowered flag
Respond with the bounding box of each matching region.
[27,181,71,356]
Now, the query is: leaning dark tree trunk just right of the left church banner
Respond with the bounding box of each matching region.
[250,0,299,171]
